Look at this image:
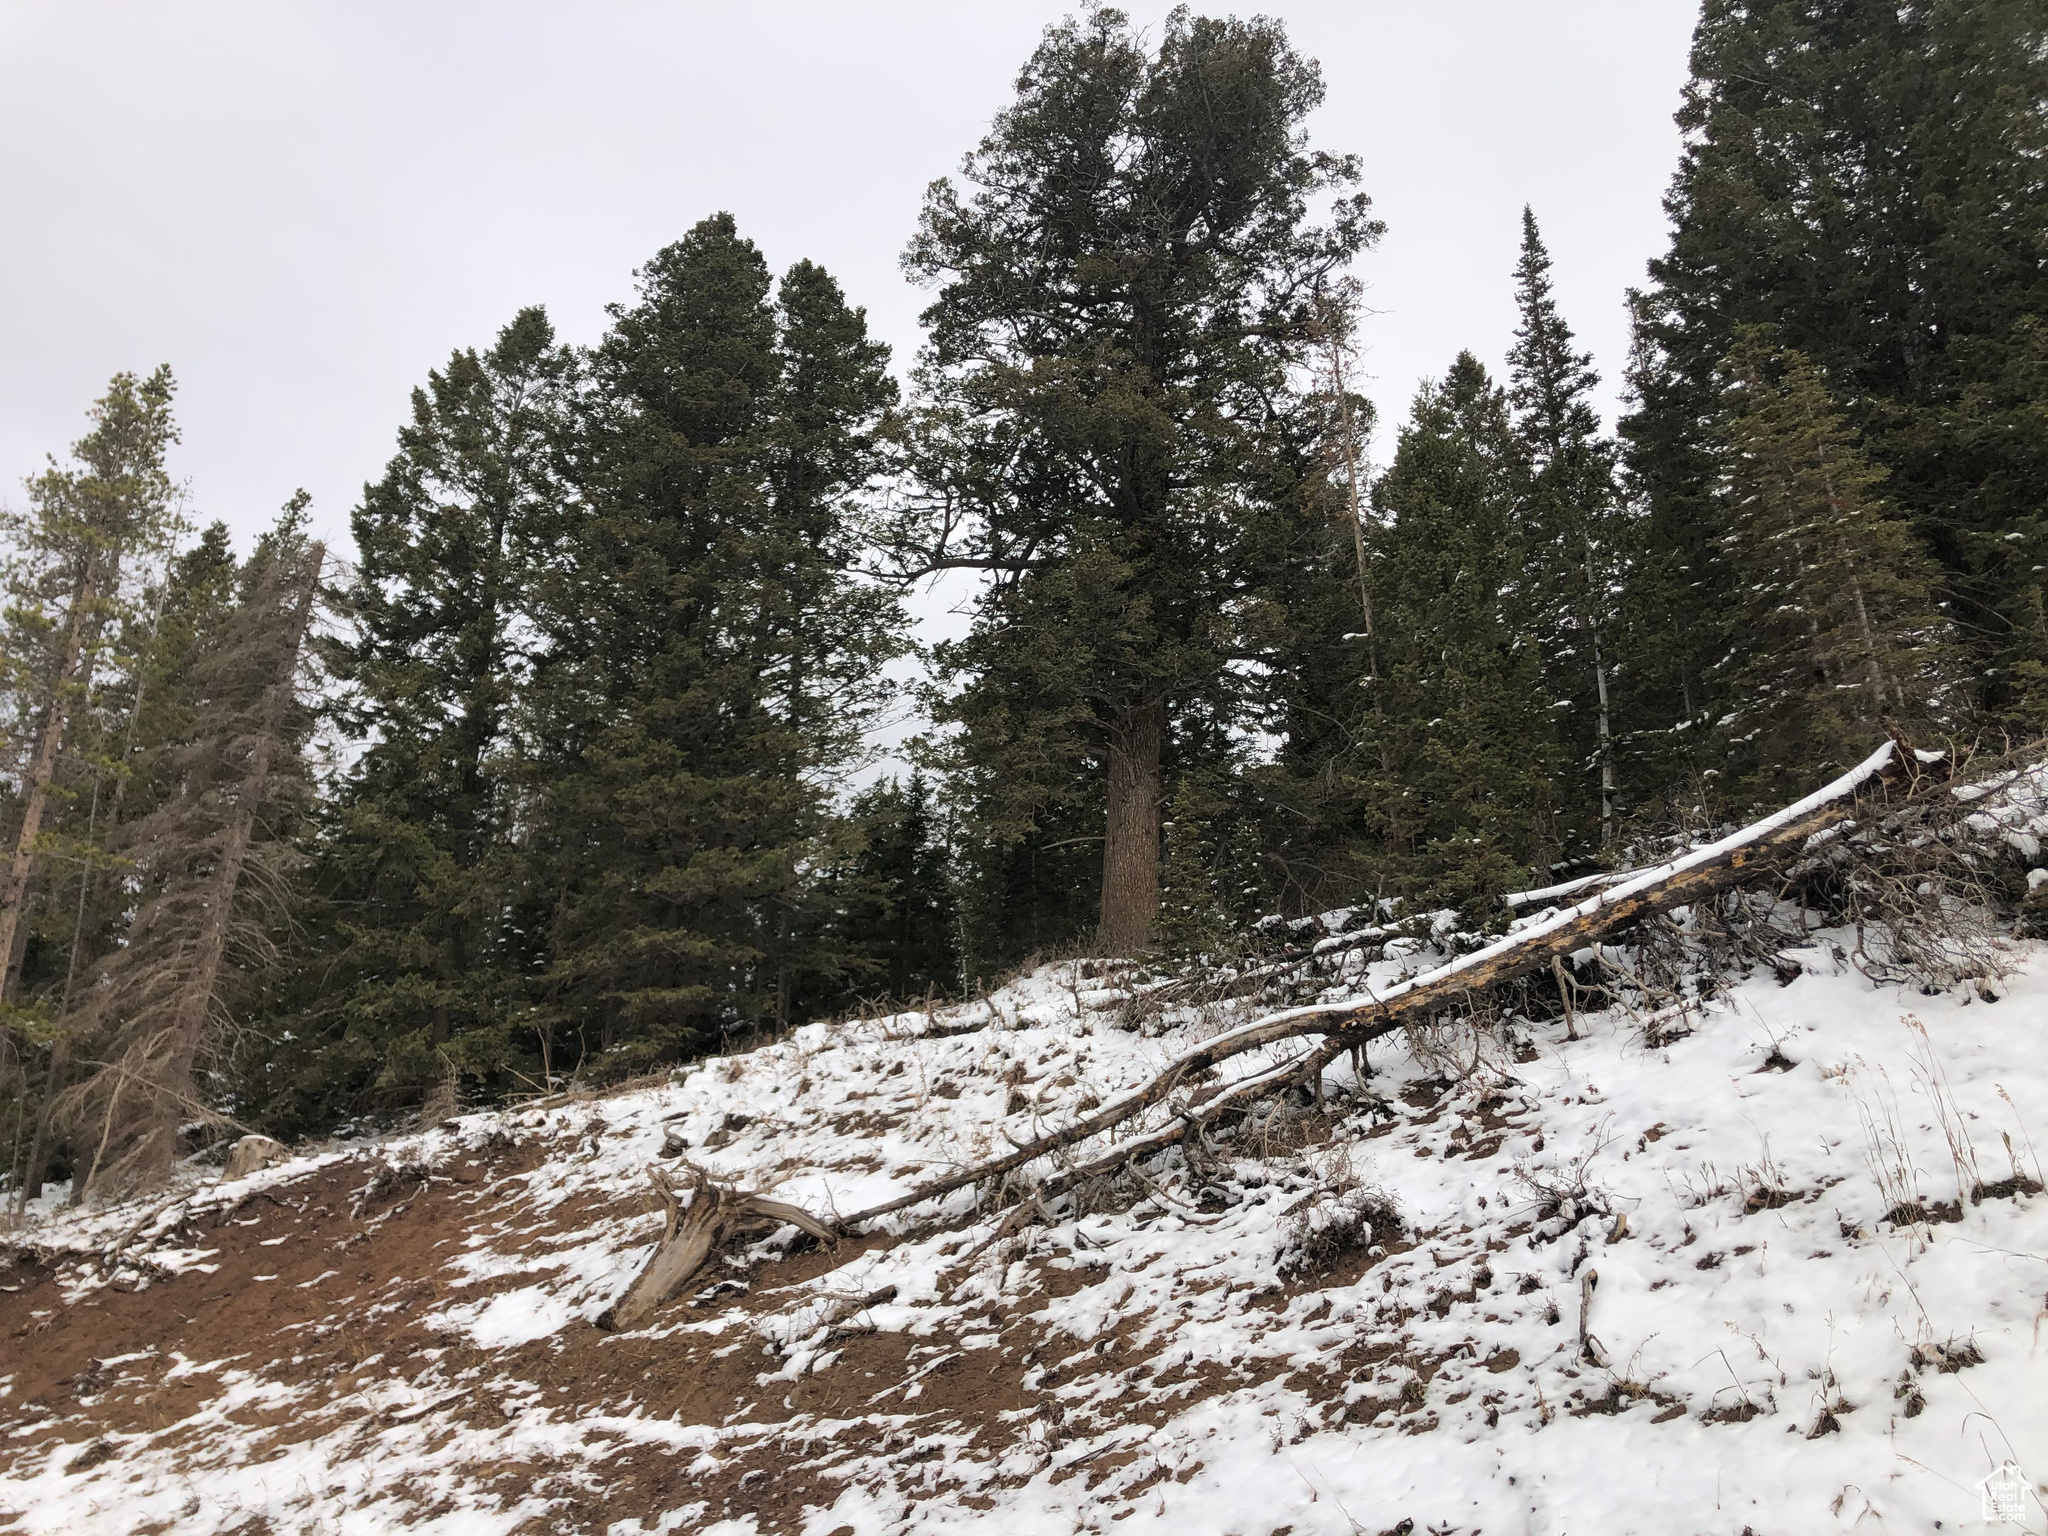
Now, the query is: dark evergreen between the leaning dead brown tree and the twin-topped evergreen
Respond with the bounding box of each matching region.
[288,309,578,1114]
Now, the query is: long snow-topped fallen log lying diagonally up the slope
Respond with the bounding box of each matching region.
[840,741,1915,1231]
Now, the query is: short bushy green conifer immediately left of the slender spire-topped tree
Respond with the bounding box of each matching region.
[1350,352,1561,915]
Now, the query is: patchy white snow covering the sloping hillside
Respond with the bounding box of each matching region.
[0,760,2048,1536]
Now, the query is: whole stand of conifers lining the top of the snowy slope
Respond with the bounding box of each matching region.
[0,0,2048,1212]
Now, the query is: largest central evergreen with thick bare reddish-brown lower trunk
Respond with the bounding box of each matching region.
[899,8,1378,954]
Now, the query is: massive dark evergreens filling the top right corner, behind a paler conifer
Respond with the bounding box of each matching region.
[1624,0,2048,721]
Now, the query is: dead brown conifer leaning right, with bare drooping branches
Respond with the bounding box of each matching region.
[57,518,324,1202]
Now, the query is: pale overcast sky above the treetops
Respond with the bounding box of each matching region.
[0,0,1698,565]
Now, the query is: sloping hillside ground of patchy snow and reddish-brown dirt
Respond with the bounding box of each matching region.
[0,913,2048,1536]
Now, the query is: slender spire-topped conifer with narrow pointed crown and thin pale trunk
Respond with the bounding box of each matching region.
[1507,207,1622,852]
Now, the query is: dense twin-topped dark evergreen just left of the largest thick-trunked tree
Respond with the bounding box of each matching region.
[522,213,899,1069]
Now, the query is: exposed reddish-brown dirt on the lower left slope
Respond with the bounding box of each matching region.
[0,1141,1466,1532]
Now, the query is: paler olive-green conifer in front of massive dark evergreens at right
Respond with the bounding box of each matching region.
[1724,328,1958,803]
